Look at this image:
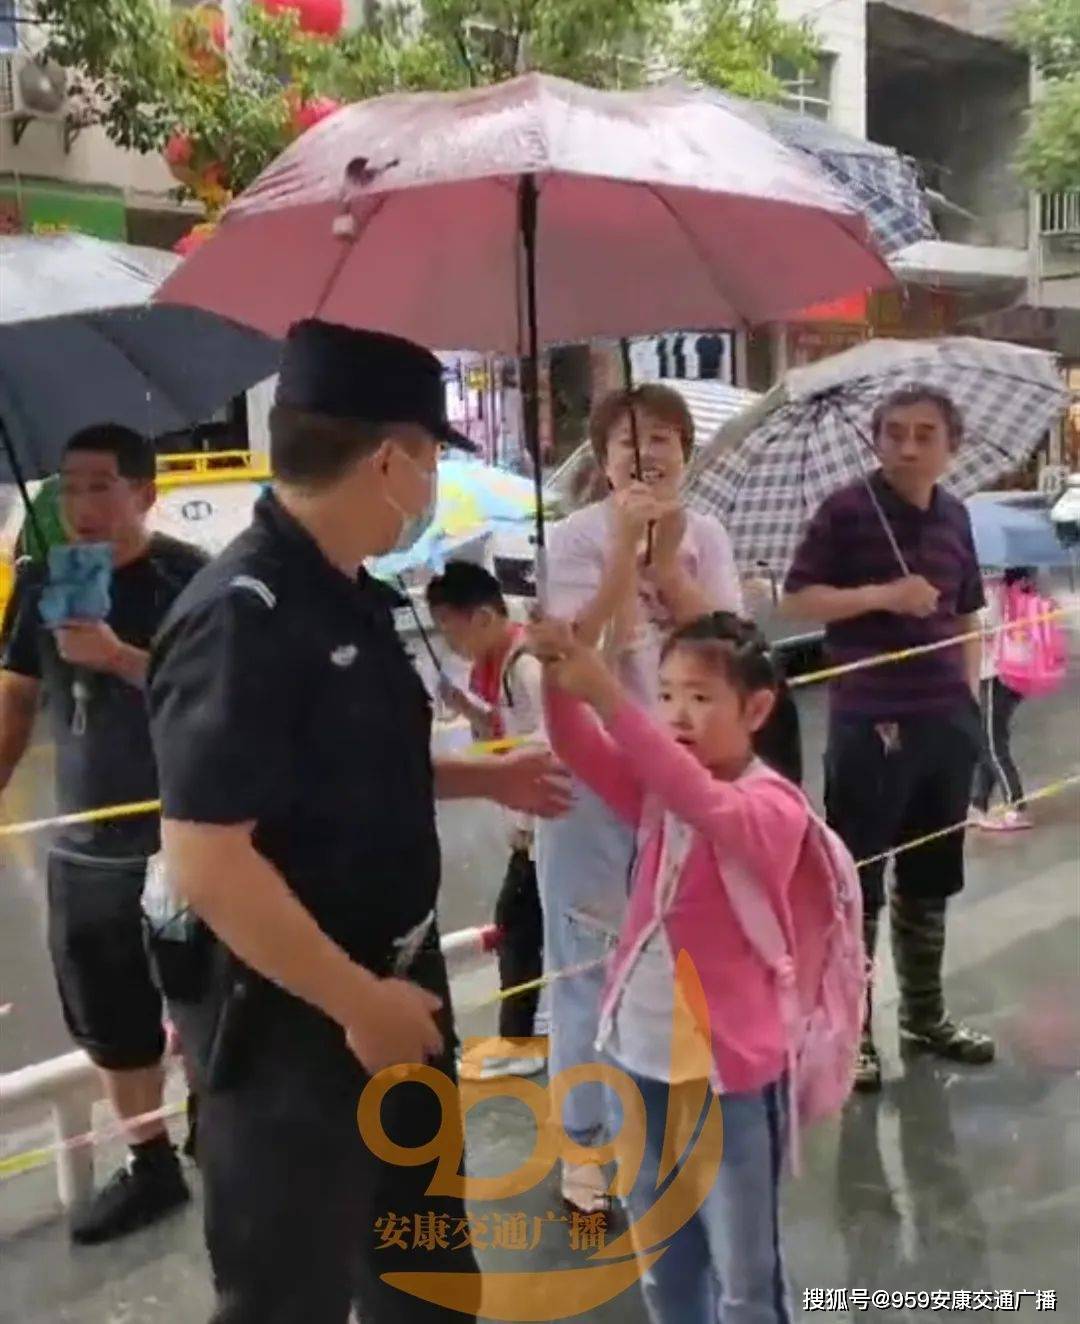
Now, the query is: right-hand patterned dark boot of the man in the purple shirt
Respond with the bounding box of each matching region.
[891,891,994,1066]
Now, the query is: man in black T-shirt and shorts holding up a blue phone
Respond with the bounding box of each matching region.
[0,424,205,1242]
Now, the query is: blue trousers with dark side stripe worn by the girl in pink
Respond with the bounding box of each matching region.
[625,1076,793,1324]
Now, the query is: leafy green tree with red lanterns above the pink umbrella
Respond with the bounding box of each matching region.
[38,0,815,217]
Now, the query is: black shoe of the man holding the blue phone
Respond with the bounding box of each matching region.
[71,1135,191,1246]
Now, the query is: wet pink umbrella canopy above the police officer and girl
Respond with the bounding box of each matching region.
[159,74,892,355]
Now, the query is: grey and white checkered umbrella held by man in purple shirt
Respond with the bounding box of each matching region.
[687,336,1068,575]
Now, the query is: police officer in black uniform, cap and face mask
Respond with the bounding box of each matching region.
[150,322,566,1324]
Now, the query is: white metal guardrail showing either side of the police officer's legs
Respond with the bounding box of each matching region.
[0,924,499,1209]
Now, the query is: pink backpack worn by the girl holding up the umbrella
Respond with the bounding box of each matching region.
[717,783,867,1173]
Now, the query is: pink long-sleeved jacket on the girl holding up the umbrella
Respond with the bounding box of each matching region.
[547,690,810,1094]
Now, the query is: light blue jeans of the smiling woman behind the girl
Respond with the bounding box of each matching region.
[536,782,634,1145]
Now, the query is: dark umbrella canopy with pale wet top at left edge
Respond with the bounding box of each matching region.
[0,234,278,482]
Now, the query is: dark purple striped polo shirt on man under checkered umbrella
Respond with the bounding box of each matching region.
[785,470,985,720]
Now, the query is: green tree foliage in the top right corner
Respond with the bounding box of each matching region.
[1015,0,1080,193]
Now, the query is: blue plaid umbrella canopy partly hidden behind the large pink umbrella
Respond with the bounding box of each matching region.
[713,93,937,253]
